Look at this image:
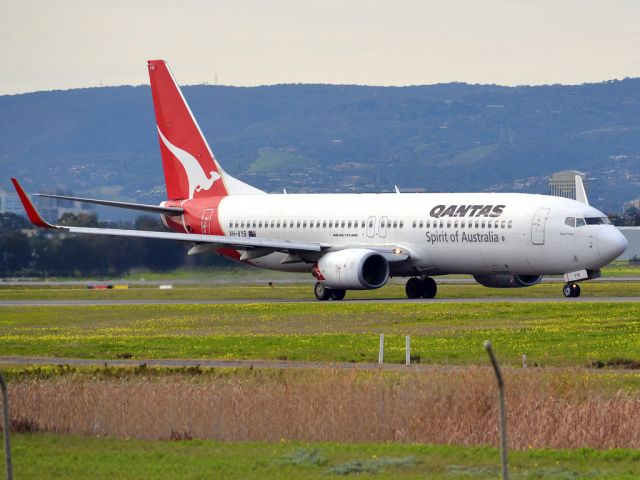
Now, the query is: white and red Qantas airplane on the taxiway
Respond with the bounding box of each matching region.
[12,60,627,300]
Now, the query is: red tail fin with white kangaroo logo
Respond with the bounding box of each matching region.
[148,60,263,200]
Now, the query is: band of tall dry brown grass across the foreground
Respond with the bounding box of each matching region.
[10,367,640,449]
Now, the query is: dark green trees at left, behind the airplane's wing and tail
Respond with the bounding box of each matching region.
[0,213,230,277]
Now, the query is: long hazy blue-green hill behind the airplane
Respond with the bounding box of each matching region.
[0,79,640,211]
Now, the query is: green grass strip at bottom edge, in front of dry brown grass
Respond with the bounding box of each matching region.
[13,434,640,480]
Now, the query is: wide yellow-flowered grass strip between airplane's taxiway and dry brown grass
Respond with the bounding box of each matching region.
[0,302,640,366]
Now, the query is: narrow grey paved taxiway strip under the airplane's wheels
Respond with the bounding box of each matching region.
[0,296,640,308]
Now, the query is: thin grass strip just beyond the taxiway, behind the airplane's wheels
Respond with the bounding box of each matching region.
[0,282,640,301]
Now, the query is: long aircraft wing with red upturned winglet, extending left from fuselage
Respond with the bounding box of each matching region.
[11,178,329,253]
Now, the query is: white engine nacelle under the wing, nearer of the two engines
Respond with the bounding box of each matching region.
[315,248,389,290]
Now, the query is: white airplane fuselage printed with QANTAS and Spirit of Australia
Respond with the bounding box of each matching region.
[211,189,621,276]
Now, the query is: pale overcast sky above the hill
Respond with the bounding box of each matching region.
[0,0,640,94]
